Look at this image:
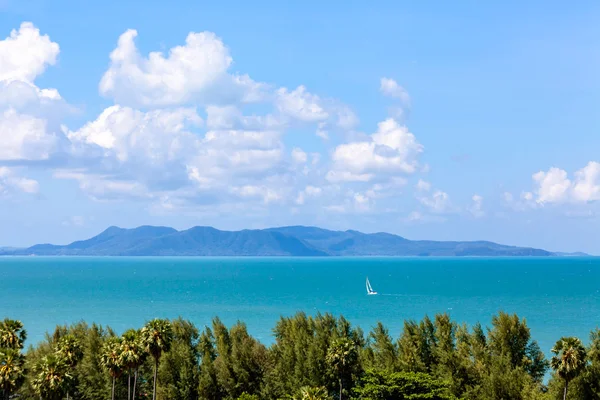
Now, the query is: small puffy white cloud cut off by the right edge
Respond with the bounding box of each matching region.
[531,161,600,204]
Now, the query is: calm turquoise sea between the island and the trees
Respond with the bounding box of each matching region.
[0,257,600,353]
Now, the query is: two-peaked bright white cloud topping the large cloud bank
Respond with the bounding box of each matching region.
[99,29,262,107]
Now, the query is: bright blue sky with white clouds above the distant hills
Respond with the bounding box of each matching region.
[0,0,600,254]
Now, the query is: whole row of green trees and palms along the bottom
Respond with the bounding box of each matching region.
[0,312,600,400]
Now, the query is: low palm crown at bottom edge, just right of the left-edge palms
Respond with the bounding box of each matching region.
[32,354,71,400]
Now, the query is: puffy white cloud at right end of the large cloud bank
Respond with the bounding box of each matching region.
[332,118,423,179]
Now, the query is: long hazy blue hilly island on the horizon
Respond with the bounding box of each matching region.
[0,226,586,257]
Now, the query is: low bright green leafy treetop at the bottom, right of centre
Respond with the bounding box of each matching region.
[354,370,455,400]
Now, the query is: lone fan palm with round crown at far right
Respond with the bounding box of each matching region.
[550,337,586,400]
